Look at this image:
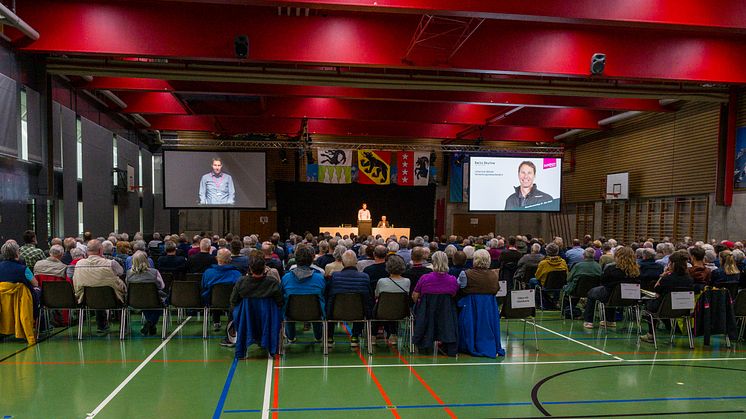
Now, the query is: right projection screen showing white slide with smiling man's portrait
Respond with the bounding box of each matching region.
[469,156,562,212]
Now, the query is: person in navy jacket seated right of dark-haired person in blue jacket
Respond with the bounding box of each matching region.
[326,250,372,348]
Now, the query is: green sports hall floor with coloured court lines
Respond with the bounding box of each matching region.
[0,311,746,419]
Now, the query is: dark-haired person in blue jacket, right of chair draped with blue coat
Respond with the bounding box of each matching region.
[282,244,326,343]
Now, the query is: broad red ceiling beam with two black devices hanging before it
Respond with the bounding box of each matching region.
[18,0,746,83]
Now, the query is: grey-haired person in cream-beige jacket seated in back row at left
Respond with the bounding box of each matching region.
[72,240,127,336]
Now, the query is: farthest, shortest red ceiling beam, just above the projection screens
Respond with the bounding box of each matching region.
[148,115,561,142]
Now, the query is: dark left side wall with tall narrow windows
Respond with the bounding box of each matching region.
[0,41,163,247]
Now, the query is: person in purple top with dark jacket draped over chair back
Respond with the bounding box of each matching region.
[412,251,459,356]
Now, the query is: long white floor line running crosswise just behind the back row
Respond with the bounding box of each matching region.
[274,358,746,369]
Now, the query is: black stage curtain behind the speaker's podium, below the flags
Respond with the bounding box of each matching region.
[275,182,435,237]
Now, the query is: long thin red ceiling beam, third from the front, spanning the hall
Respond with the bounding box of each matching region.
[85,77,670,112]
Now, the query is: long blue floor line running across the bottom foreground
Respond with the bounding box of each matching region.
[223,396,746,413]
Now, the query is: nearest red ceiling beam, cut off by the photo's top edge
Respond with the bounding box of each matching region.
[201,0,746,30]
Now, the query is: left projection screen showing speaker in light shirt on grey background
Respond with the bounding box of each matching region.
[163,150,267,208]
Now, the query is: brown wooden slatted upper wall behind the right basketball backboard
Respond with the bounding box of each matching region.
[563,103,720,202]
